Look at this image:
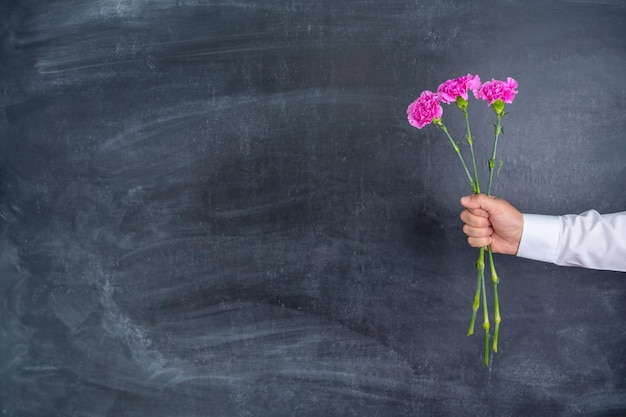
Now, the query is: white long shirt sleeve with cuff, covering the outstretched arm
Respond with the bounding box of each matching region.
[517,210,626,272]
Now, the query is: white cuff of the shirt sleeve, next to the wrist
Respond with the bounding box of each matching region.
[517,214,561,263]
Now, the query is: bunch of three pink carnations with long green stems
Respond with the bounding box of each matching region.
[407,74,517,365]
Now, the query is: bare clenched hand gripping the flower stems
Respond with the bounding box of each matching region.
[461,194,524,255]
